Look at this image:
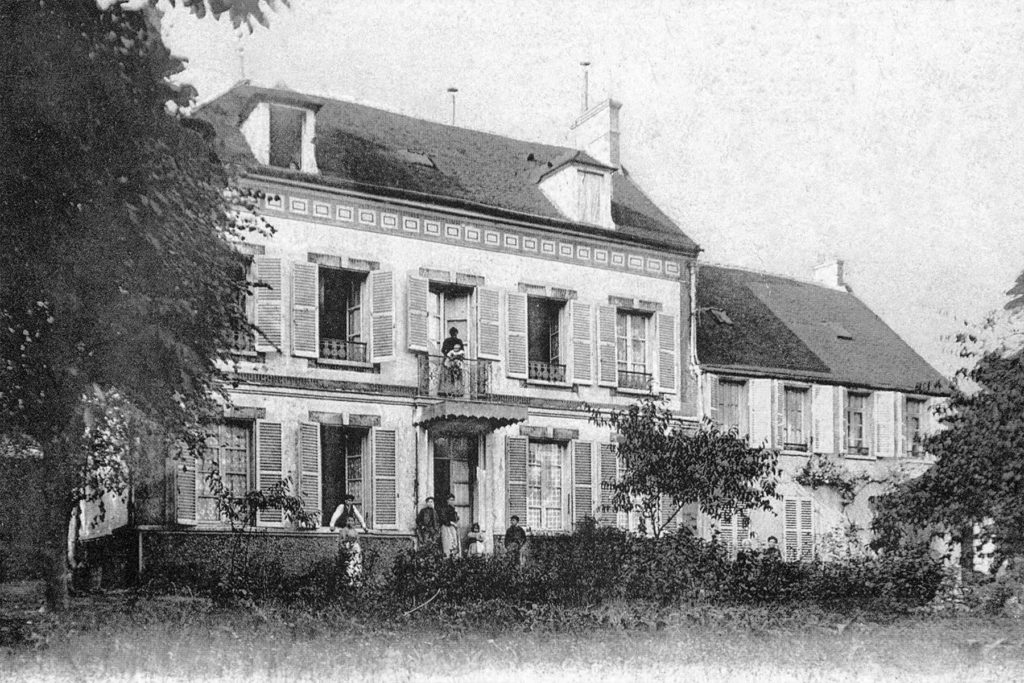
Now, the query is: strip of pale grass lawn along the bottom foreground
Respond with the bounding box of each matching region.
[0,592,1024,683]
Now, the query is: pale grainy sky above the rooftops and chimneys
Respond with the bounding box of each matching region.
[163,0,1024,373]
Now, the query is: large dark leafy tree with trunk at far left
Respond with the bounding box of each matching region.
[0,0,276,607]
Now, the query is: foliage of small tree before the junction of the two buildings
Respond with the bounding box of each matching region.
[591,398,779,536]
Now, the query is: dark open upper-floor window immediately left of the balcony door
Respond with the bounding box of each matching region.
[317,266,369,362]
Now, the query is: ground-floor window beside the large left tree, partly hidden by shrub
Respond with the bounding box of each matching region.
[196,420,253,522]
